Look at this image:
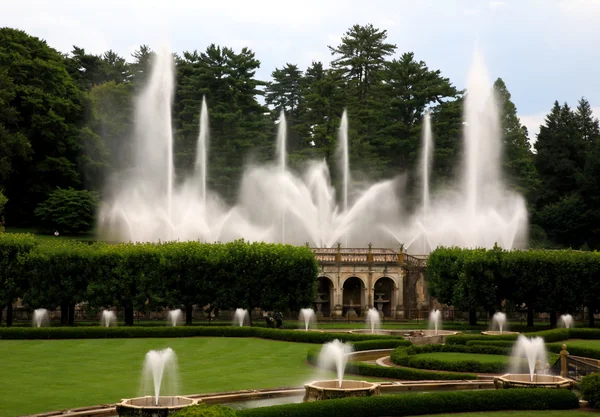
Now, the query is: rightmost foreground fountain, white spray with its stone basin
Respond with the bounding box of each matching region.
[494,335,573,389]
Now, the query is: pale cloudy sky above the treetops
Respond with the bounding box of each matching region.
[0,0,600,139]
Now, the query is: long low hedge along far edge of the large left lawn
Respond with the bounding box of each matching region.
[0,326,406,343]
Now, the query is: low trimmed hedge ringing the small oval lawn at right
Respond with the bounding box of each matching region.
[391,345,510,373]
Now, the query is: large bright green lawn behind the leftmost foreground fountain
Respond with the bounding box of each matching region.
[0,338,352,417]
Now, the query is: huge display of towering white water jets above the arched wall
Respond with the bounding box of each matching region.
[99,45,527,253]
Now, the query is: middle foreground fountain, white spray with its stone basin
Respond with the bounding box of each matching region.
[304,339,380,402]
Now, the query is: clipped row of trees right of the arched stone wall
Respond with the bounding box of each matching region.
[427,247,600,327]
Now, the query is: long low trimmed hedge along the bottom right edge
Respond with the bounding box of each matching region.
[236,389,579,417]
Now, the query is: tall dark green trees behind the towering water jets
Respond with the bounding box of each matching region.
[0,25,600,249]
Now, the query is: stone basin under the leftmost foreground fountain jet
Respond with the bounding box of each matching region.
[117,395,201,417]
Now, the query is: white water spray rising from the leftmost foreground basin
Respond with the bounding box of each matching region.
[140,348,179,405]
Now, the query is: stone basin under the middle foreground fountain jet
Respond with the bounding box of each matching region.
[304,379,380,402]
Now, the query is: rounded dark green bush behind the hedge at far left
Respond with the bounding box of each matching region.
[35,188,98,233]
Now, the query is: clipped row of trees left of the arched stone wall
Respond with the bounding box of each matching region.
[0,233,317,325]
